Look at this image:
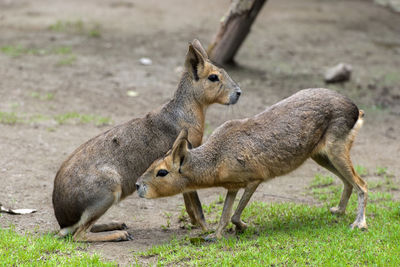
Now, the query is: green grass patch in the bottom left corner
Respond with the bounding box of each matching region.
[0,228,116,266]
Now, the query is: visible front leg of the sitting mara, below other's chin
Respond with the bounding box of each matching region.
[183,191,208,231]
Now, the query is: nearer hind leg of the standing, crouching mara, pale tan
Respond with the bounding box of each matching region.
[327,144,368,229]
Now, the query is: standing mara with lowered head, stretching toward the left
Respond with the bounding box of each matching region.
[138,89,367,240]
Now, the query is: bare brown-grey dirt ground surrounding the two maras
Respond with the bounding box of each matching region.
[0,0,400,265]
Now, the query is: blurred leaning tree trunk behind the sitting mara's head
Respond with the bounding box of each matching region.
[207,0,266,65]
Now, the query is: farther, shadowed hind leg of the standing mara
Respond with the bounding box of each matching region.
[311,154,353,214]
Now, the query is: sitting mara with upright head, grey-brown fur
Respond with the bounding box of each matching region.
[53,40,241,241]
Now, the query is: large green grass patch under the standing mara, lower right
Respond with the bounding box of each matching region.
[134,175,400,266]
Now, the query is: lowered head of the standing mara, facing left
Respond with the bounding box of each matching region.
[136,130,194,198]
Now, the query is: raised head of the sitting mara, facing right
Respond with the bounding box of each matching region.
[185,39,242,105]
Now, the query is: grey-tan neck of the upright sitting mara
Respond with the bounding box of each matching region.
[161,72,208,146]
